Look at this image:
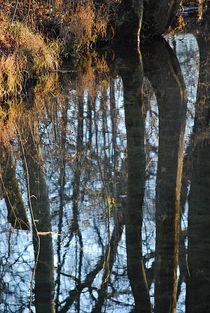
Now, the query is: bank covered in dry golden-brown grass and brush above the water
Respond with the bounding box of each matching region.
[0,0,205,98]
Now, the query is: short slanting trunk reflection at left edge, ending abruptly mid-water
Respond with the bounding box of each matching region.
[0,147,29,230]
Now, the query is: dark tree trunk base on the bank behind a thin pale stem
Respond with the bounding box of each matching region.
[115,0,182,44]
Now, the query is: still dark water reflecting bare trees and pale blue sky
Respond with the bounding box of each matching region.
[0,16,210,313]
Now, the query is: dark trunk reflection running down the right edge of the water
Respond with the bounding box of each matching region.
[186,29,210,313]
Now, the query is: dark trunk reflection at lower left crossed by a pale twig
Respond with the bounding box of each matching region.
[23,127,55,313]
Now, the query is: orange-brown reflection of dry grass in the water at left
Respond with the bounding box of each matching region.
[0,73,63,147]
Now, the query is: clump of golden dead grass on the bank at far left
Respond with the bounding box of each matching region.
[0,16,60,97]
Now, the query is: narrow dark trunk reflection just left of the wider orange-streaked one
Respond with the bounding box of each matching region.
[117,45,151,313]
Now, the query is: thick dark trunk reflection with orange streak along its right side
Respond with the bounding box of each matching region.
[145,40,186,313]
